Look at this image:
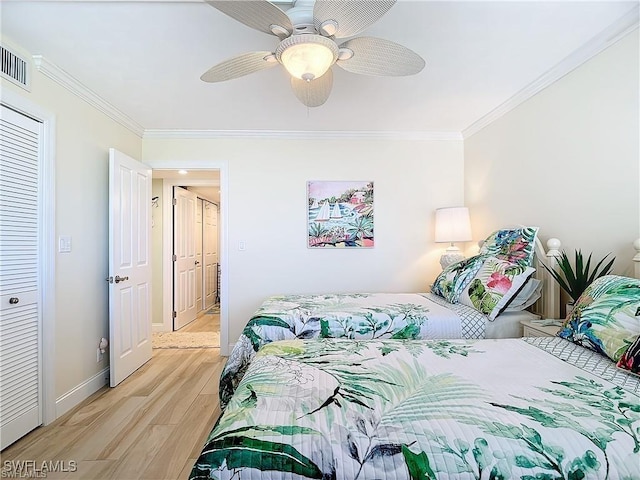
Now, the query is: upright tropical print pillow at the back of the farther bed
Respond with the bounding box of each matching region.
[480,227,538,266]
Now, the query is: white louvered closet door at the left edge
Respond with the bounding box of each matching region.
[0,106,42,448]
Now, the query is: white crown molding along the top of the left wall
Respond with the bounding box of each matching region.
[32,55,144,137]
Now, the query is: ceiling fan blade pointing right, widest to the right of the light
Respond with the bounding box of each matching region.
[336,37,425,77]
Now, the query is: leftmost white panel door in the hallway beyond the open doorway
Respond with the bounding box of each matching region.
[173,187,198,330]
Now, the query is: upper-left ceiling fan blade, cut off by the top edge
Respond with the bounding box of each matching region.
[206,0,293,37]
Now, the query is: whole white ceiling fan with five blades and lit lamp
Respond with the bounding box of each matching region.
[200,0,425,107]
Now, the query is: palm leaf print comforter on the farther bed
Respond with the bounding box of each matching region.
[220,293,487,408]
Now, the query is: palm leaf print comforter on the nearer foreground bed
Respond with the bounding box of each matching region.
[191,337,640,480]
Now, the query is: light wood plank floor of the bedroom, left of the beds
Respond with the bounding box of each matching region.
[0,348,226,480]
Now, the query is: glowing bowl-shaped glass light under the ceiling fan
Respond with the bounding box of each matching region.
[276,34,338,81]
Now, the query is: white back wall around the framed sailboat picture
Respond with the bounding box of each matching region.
[143,139,463,342]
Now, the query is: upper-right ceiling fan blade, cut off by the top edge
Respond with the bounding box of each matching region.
[313,0,396,38]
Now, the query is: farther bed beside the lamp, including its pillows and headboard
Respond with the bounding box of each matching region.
[220,226,560,408]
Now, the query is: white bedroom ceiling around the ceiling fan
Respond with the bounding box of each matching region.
[0,0,638,132]
